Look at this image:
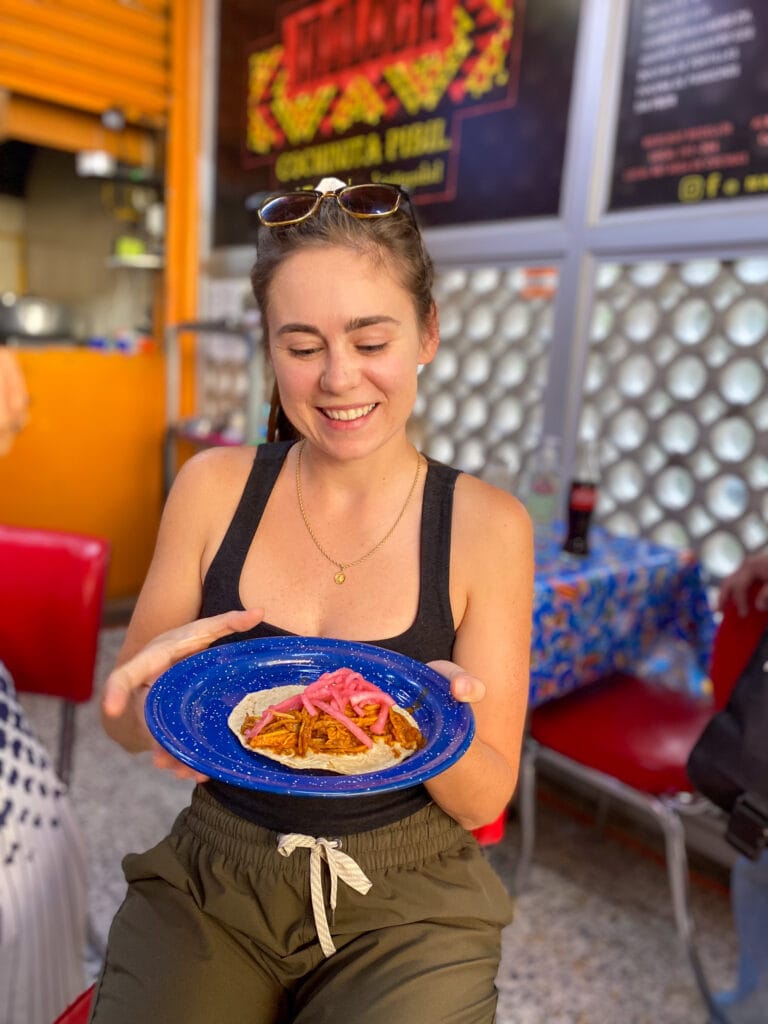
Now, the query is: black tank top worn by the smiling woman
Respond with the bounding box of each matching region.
[201,441,459,836]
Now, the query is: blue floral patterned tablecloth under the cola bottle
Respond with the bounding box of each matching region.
[530,526,715,706]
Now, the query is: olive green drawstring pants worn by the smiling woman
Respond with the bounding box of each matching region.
[90,786,511,1024]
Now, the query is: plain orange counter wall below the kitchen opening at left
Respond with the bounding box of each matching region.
[0,347,165,599]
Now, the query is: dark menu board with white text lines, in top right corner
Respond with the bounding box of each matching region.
[609,0,768,210]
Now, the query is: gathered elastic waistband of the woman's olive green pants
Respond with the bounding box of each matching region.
[180,785,474,871]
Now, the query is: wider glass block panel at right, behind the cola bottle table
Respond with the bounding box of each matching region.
[579,257,768,579]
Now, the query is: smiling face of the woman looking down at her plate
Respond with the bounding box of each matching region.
[267,247,438,458]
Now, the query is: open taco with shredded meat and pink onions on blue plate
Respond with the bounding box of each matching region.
[227,669,424,775]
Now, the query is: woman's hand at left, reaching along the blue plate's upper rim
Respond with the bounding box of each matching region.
[101,608,264,718]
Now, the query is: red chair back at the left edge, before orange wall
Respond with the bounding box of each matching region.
[0,525,110,703]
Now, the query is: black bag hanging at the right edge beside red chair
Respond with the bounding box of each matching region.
[687,630,768,860]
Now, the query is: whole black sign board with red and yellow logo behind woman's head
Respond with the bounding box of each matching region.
[213,0,580,247]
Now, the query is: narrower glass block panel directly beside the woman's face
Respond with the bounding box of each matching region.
[413,266,557,475]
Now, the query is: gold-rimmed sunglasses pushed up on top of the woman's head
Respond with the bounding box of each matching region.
[258,184,415,227]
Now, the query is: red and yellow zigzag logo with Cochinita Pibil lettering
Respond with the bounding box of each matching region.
[246,0,522,202]
